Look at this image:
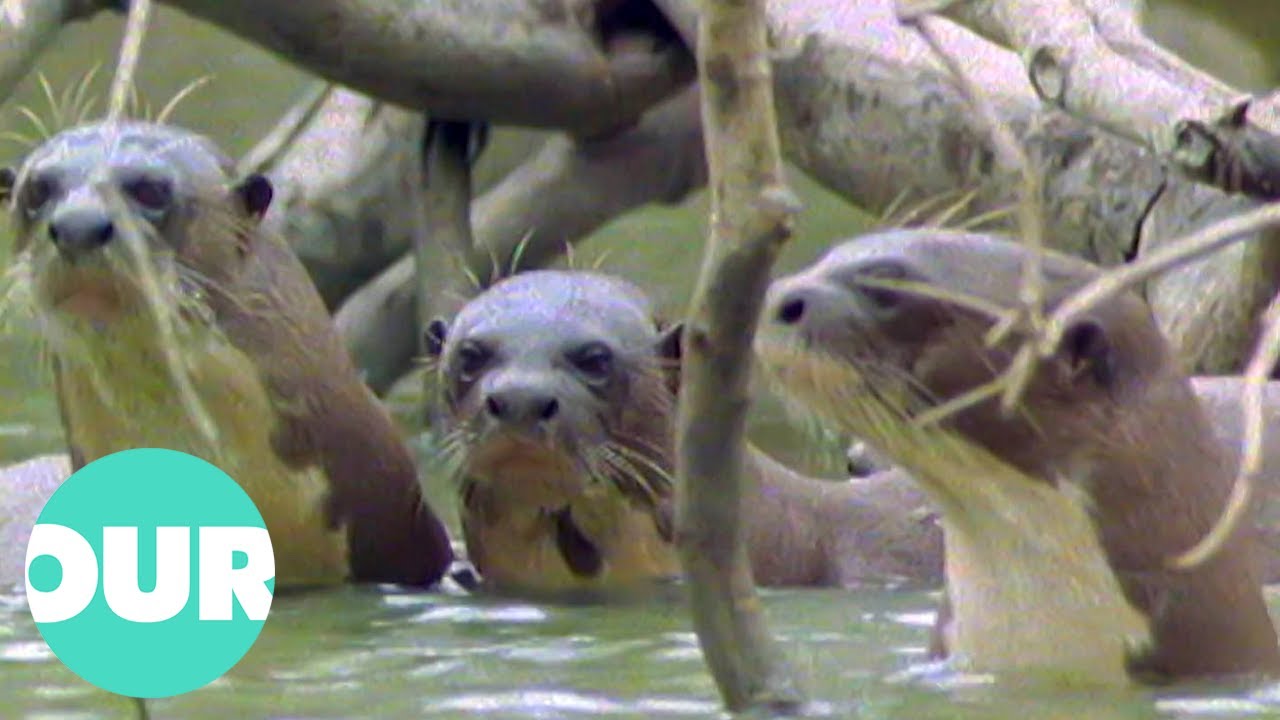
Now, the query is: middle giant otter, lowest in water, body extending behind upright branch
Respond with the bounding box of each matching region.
[428,270,942,593]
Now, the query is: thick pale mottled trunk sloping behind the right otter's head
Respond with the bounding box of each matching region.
[762,0,1280,373]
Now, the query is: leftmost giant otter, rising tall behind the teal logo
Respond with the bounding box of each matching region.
[0,122,452,587]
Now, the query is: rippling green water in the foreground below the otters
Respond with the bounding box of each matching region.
[0,588,1280,720]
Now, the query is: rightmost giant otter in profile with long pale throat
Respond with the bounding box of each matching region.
[756,231,1280,683]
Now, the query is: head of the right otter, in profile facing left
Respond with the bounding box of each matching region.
[756,232,1169,477]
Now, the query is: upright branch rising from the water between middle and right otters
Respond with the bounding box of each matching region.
[676,0,801,711]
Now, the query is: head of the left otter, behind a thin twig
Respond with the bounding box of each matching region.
[0,122,271,329]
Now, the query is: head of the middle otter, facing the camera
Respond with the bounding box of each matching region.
[426,270,678,511]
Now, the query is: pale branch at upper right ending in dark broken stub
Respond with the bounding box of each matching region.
[926,0,1280,199]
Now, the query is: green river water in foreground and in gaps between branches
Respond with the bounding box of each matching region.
[0,0,1280,720]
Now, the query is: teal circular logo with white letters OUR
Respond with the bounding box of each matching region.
[27,448,275,698]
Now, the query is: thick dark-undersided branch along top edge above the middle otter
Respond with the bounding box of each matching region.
[148,0,692,135]
